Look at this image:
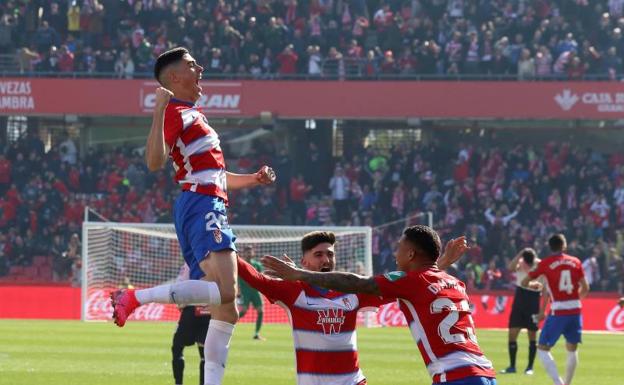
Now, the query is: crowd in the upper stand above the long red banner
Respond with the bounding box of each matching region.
[0,0,624,79]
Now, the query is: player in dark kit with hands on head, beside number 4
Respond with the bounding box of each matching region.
[501,248,541,375]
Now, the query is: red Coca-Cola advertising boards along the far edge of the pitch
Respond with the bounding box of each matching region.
[0,286,624,331]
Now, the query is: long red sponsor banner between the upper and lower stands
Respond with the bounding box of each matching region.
[0,78,624,120]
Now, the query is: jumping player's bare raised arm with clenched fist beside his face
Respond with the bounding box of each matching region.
[145,87,173,171]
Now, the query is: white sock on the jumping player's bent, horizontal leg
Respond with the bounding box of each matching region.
[135,280,221,306]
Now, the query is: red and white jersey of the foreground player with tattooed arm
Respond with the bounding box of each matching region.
[375,268,496,383]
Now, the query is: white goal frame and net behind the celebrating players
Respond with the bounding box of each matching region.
[82,222,373,323]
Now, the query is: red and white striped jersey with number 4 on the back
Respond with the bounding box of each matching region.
[529,254,585,315]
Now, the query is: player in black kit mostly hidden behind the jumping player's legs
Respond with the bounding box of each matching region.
[171,263,210,385]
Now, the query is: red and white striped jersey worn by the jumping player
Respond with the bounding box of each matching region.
[164,99,227,203]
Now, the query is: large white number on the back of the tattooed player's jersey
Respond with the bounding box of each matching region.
[431,298,477,344]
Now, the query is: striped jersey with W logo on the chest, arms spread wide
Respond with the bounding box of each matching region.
[238,258,390,385]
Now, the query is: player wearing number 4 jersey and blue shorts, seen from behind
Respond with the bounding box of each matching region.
[522,234,589,385]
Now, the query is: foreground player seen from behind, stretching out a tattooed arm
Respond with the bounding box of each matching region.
[262,225,496,385]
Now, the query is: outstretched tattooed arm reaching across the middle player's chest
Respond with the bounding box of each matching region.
[262,256,381,295]
